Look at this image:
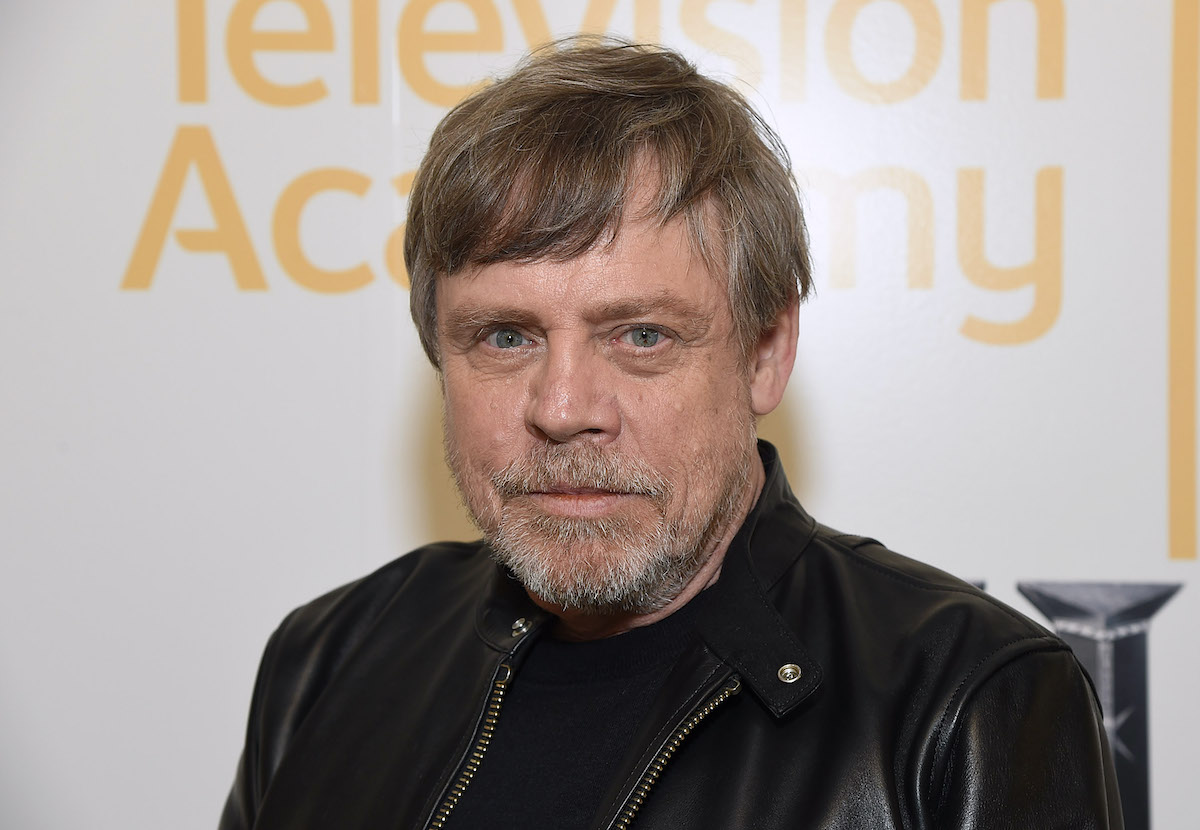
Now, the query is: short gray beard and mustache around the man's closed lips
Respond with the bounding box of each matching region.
[450,441,754,614]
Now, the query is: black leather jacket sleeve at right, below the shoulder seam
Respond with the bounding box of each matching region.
[930,646,1124,830]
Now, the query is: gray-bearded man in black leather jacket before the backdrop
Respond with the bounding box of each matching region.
[222,40,1122,830]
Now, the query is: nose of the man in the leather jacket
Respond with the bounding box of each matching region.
[526,345,620,444]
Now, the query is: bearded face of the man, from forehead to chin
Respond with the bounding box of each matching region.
[437,200,757,613]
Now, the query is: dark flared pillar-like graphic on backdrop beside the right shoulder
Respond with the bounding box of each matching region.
[1016,582,1181,830]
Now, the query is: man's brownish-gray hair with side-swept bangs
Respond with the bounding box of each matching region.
[404,37,811,366]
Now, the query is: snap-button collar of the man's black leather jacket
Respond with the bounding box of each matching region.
[475,441,821,717]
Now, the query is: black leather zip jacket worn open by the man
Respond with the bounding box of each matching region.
[221,445,1122,830]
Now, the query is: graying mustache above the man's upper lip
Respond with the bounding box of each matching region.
[492,444,671,499]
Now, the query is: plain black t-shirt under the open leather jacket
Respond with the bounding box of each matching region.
[446,607,694,830]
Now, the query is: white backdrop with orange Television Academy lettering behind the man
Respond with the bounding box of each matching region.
[0,0,1200,830]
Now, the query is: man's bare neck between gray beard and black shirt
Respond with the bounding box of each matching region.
[529,453,767,640]
